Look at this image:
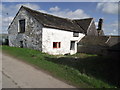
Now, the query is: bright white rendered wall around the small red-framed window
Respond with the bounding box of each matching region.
[42,28,85,55]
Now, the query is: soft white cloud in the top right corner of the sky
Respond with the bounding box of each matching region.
[97,2,118,14]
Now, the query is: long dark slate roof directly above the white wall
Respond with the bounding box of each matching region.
[21,6,93,34]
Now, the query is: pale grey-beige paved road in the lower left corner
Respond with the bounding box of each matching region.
[2,54,74,88]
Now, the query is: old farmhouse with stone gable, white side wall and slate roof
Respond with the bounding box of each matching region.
[8,6,103,55]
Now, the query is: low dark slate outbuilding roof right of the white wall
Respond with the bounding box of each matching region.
[78,36,120,47]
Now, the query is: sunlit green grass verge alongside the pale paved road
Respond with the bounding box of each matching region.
[2,46,115,88]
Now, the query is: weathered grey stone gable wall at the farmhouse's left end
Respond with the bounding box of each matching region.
[8,8,42,51]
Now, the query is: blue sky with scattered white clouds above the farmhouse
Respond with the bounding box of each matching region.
[0,2,119,35]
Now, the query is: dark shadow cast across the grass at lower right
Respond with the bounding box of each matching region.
[46,56,120,87]
